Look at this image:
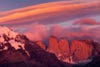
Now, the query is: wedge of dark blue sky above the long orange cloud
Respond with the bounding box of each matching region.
[0,0,56,11]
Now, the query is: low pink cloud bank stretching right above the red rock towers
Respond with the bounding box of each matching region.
[25,24,100,42]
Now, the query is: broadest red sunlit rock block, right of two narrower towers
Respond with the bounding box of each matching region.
[71,40,93,62]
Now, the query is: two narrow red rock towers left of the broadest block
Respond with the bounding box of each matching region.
[47,36,70,60]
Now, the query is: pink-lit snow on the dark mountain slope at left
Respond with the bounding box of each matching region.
[0,26,30,56]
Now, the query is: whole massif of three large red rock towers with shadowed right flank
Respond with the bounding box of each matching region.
[48,37,100,64]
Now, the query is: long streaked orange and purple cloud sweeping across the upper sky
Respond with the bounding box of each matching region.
[0,2,100,25]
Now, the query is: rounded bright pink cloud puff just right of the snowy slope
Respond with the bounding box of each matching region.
[25,24,48,41]
